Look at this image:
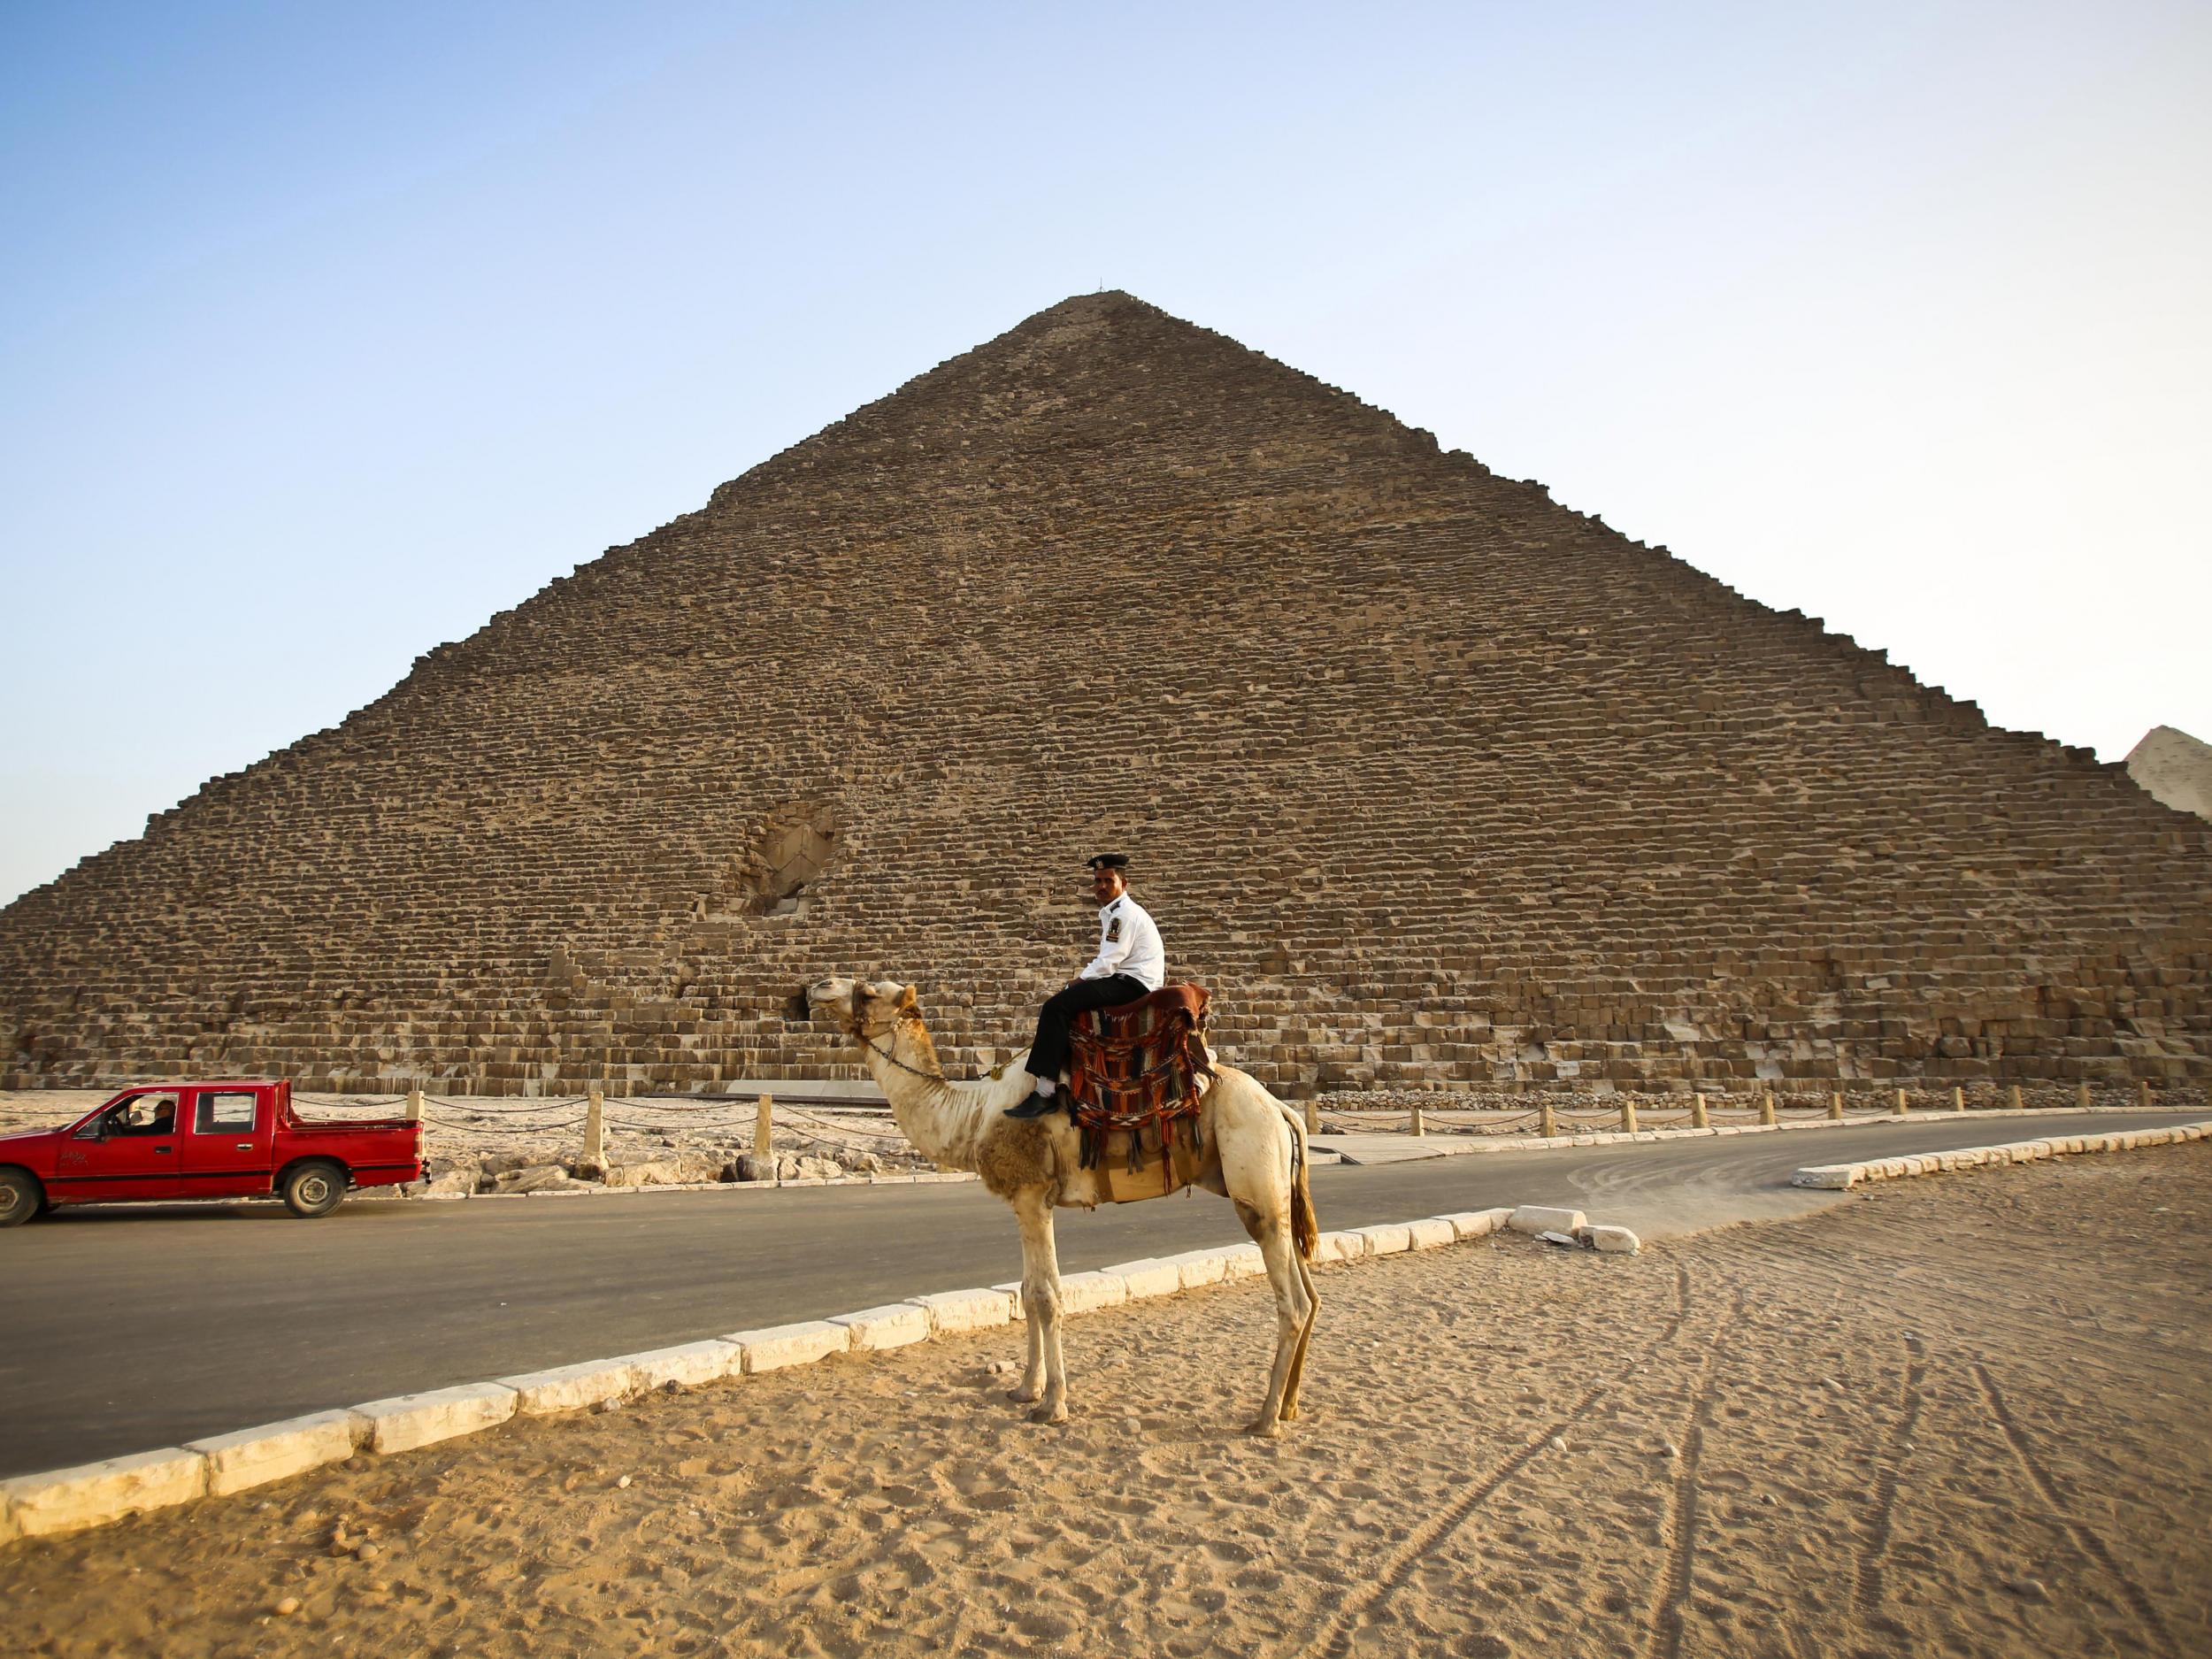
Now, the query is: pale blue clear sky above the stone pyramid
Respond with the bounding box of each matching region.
[0,0,2212,901]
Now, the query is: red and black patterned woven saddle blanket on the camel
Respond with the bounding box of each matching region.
[1069,985,1215,1203]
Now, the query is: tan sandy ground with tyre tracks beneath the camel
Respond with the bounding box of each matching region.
[12,1146,2212,1659]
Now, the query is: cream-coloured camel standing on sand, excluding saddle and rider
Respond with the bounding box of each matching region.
[805,978,1321,1436]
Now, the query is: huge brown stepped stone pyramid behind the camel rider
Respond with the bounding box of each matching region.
[0,295,2212,1095]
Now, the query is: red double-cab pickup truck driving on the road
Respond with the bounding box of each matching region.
[0,1079,423,1228]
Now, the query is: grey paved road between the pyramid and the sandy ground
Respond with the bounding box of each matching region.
[0,1113,2203,1478]
